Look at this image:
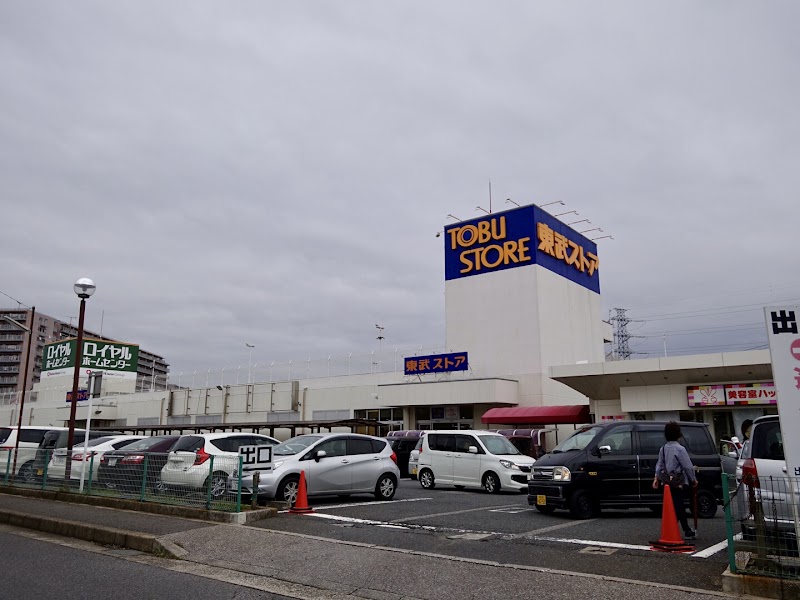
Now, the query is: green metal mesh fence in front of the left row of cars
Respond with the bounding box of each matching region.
[0,447,242,512]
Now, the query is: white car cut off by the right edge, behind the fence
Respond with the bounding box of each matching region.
[737,415,800,553]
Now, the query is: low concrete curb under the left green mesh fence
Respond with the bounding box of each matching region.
[0,485,278,525]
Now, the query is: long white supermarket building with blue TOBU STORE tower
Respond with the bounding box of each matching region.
[0,205,775,446]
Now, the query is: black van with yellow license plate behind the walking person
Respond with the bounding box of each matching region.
[528,421,722,519]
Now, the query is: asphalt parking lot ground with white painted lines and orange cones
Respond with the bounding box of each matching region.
[258,479,727,590]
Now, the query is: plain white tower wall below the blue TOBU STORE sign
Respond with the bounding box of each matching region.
[445,265,605,406]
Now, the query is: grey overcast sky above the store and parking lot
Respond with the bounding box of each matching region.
[0,0,800,380]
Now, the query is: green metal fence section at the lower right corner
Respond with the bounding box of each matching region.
[722,474,800,579]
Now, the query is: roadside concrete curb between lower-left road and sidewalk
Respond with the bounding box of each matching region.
[0,510,186,558]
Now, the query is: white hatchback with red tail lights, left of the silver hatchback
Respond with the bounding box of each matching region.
[161,432,280,498]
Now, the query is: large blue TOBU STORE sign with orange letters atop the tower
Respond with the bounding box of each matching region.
[444,205,600,294]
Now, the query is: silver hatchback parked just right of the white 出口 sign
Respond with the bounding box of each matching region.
[236,433,400,504]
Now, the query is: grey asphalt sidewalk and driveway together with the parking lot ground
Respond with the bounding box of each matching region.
[0,480,744,600]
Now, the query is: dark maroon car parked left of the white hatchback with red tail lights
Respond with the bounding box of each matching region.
[97,435,181,493]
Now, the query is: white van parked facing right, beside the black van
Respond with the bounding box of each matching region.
[417,430,536,493]
